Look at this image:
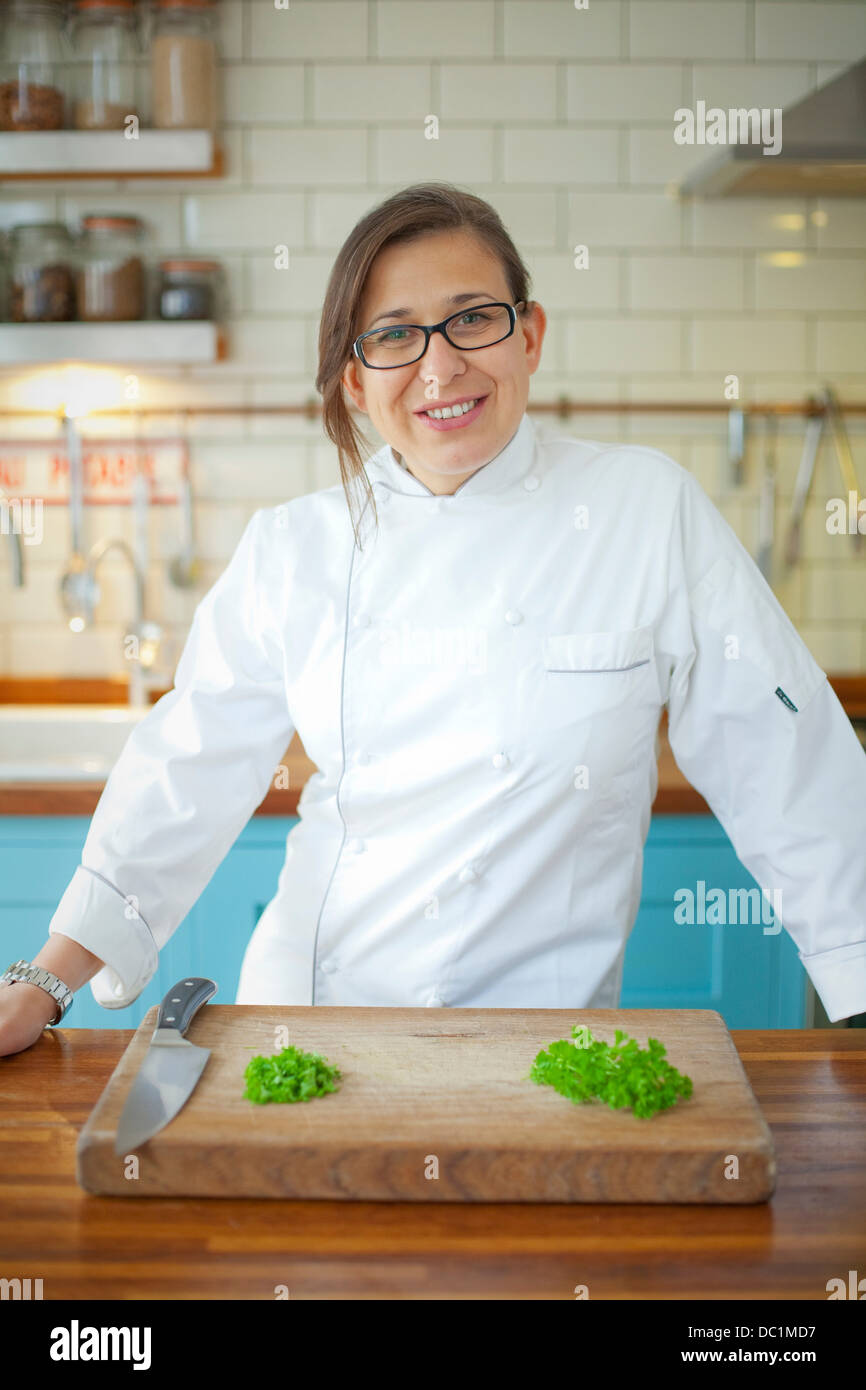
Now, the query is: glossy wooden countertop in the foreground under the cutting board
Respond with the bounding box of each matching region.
[0,1029,866,1301]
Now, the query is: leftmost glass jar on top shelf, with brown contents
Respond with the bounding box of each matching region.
[0,0,68,131]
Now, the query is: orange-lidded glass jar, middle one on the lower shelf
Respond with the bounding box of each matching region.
[76,213,146,322]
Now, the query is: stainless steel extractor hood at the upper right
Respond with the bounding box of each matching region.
[680,58,866,197]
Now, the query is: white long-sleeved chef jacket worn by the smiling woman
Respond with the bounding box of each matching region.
[50,414,866,1020]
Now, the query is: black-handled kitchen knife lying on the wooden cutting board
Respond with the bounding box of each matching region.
[114,976,217,1155]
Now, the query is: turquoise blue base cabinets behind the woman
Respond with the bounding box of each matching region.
[0,816,806,1029]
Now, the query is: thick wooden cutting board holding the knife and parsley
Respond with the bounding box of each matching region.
[76,1004,776,1204]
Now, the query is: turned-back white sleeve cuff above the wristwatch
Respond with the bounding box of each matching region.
[49,865,158,1009]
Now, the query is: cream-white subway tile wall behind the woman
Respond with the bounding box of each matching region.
[0,0,866,676]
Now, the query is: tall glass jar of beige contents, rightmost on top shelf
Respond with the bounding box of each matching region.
[150,0,217,131]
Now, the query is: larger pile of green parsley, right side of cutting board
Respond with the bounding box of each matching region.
[528,1024,692,1118]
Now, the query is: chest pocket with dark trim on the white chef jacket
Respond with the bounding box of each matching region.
[541,627,657,727]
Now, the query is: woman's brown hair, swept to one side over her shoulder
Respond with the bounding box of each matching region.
[316,183,530,546]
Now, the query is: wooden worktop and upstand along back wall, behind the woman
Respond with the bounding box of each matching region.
[0,676,866,816]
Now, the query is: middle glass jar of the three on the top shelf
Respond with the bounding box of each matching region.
[71,0,139,131]
